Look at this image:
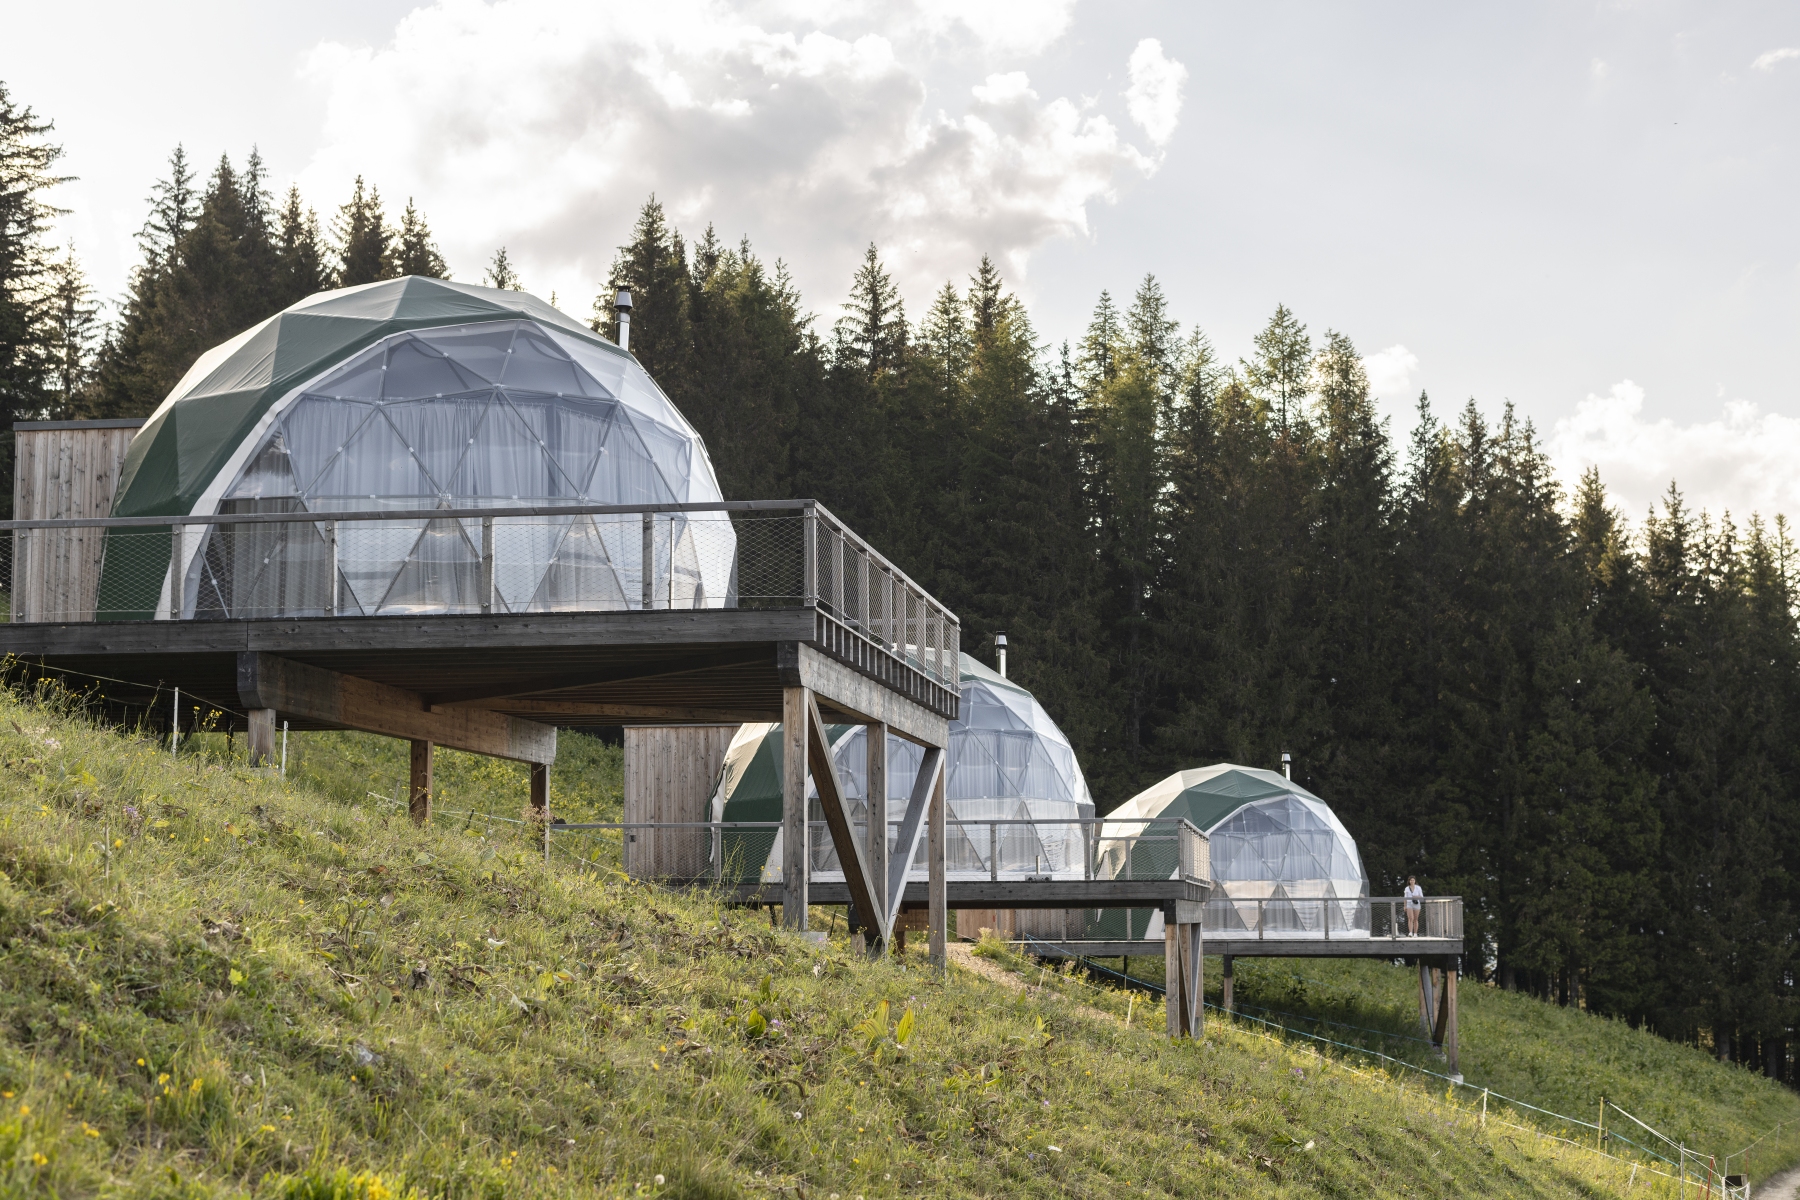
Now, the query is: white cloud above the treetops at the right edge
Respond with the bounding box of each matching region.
[1548,380,1800,520]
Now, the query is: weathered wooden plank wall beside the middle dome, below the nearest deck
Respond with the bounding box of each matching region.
[625,725,738,880]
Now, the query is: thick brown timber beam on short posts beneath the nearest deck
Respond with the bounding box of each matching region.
[238,651,556,765]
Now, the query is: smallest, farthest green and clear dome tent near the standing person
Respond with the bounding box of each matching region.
[1102,763,1368,937]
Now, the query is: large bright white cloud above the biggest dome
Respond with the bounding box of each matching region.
[301,0,1152,311]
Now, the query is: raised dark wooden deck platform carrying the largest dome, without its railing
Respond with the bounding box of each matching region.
[0,608,958,743]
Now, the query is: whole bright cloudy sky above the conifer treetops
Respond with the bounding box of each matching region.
[0,0,1800,516]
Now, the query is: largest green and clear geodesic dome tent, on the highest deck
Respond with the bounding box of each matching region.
[101,277,736,619]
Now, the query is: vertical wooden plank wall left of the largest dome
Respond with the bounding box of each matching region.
[13,421,142,621]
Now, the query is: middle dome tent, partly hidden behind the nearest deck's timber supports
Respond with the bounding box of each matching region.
[713,655,1094,880]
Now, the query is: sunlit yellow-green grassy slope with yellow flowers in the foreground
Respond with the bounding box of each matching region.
[0,693,1792,1200]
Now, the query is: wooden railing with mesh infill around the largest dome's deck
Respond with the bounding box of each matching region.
[0,500,961,693]
